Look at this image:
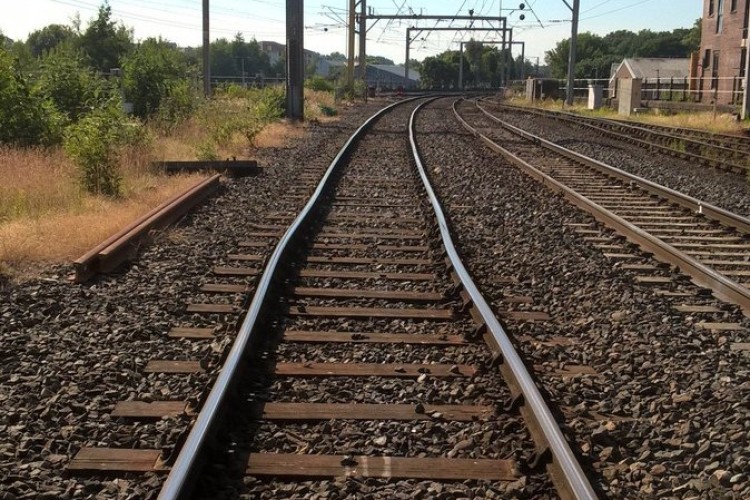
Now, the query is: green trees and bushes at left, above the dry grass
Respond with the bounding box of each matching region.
[0,3,290,196]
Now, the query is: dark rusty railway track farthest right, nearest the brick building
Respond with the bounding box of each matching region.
[481,99,750,174]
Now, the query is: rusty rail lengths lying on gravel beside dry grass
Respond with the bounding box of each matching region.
[73,174,221,283]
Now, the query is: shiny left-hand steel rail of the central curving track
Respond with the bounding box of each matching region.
[158,97,426,500]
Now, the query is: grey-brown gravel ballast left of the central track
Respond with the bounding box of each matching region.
[0,102,383,499]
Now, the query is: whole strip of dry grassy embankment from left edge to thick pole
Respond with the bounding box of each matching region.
[0,91,334,279]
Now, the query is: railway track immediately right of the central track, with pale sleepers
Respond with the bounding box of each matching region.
[454,97,750,311]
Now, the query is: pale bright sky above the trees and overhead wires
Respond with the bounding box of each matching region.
[0,0,703,64]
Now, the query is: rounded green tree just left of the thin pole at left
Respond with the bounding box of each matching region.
[123,38,187,118]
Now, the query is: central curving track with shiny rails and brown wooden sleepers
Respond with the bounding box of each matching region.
[159,98,596,499]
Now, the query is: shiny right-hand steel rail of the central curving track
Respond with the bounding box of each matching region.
[409,101,598,499]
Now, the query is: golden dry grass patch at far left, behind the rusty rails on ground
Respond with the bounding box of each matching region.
[0,143,207,278]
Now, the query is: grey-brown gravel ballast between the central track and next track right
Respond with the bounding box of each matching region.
[419,100,750,498]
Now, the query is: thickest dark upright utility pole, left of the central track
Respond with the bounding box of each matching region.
[286,0,305,120]
